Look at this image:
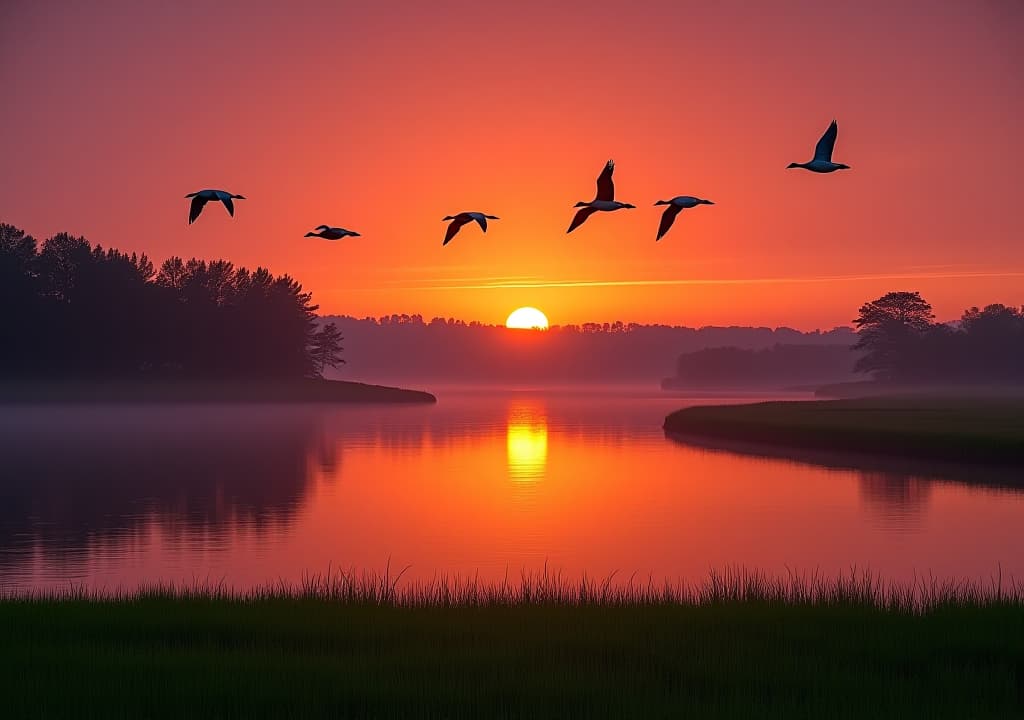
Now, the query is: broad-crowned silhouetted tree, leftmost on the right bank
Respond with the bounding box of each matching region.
[853,292,935,380]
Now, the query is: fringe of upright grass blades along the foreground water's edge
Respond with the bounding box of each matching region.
[9,563,1024,613]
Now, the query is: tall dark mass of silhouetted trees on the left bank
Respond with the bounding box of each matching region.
[0,223,344,379]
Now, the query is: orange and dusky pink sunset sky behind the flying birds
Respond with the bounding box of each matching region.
[0,0,1024,329]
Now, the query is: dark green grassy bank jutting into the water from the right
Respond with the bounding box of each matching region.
[664,396,1024,466]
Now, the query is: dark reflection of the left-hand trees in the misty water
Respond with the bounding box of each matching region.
[0,406,323,578]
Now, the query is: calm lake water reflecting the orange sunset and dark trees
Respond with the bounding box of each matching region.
[0,391,1024,590]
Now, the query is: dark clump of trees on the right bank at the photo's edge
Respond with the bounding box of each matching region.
[853,291,1024,384]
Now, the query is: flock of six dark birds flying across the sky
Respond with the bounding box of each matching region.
[185,120,850,245]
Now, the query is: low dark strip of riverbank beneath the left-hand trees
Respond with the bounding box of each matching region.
[0,378,437,405]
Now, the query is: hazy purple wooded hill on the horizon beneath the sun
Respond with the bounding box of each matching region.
[319,315,856,385]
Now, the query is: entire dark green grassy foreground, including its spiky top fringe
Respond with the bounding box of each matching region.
[0,570,1024,718]
